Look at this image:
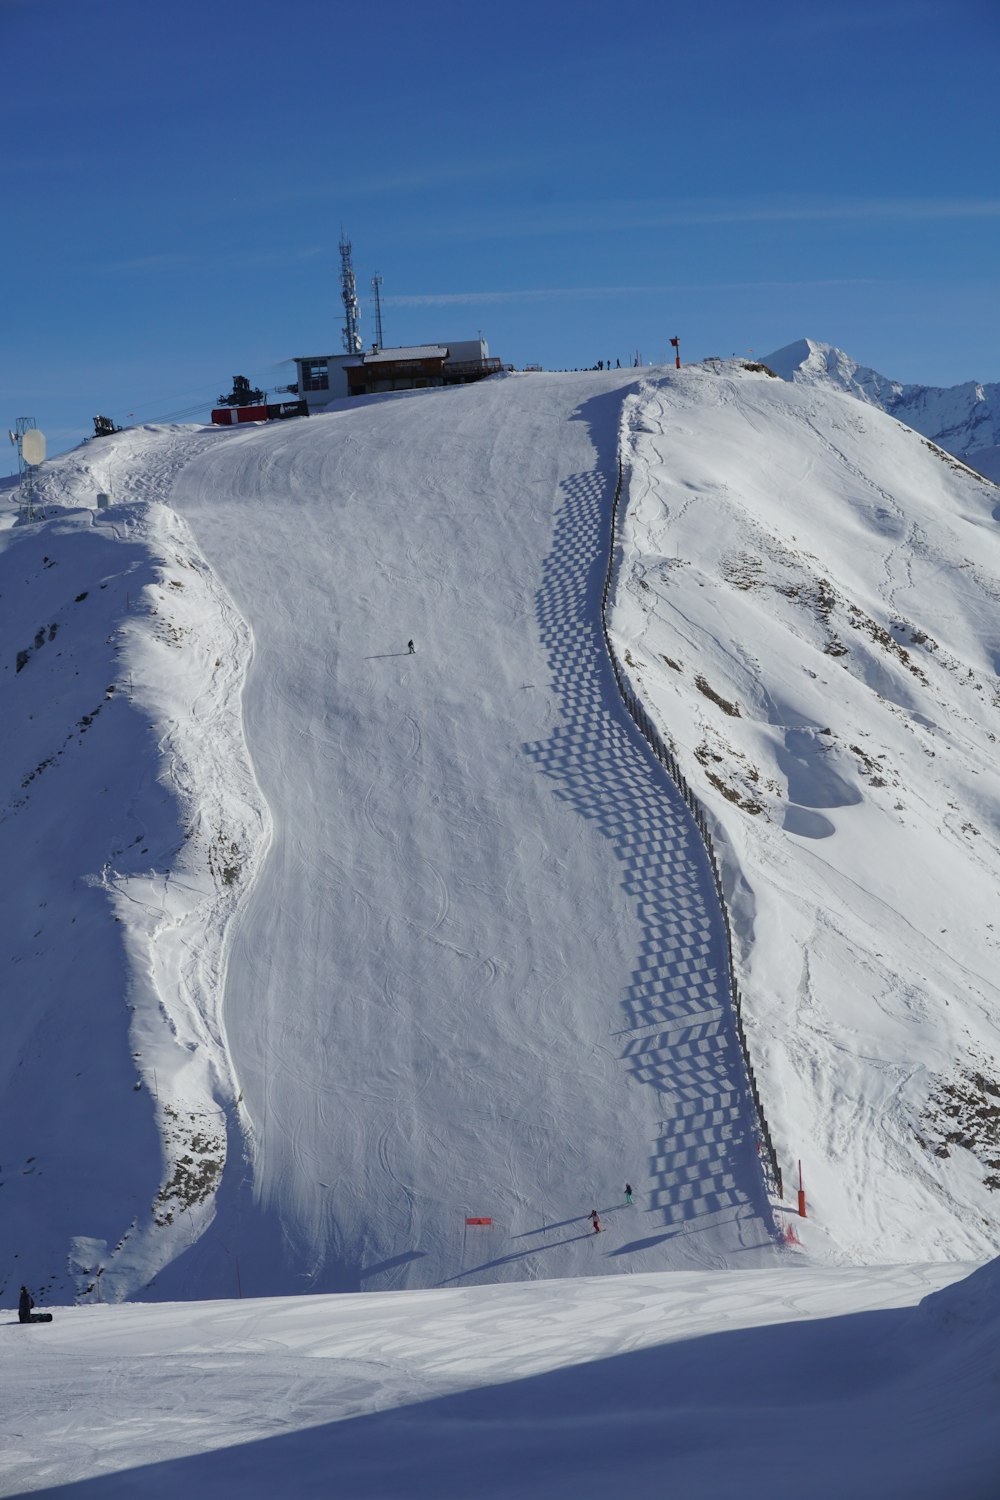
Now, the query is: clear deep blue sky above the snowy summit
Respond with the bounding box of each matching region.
[0,0,1000,473]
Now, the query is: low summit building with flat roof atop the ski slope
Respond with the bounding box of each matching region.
[289,338,501,411]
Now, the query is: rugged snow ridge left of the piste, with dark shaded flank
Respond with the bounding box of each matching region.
[0,431,268,1301]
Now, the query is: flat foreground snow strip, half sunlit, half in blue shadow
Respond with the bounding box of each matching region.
[0,1262,1000,1500]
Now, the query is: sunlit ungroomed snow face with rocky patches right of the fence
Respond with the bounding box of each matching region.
[612,365,1000,1260]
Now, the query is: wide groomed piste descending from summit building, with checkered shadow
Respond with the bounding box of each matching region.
[158,377,772,1289]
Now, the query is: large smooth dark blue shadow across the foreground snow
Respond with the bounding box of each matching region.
[36,1289,1000,1500]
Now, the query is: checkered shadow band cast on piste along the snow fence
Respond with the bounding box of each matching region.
[525,473,771,1251]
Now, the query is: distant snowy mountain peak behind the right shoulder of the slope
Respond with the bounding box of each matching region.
[765,339,1000,483]
